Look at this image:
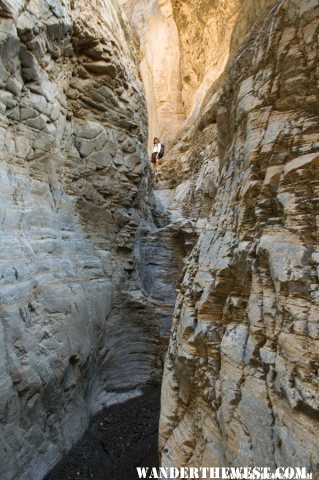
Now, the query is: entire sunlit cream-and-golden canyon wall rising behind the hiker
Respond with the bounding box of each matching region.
[121,0,280,149]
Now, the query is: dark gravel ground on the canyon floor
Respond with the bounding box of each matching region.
[45,387,160,480]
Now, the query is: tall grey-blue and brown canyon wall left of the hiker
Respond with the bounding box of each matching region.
[0,0,160,480]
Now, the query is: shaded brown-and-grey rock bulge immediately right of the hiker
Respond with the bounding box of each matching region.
[154,112,219,232]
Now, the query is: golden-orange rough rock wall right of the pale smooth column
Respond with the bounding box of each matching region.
[171,0,275,122]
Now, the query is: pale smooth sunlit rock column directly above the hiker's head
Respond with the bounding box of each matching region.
[121,0,185,147]
